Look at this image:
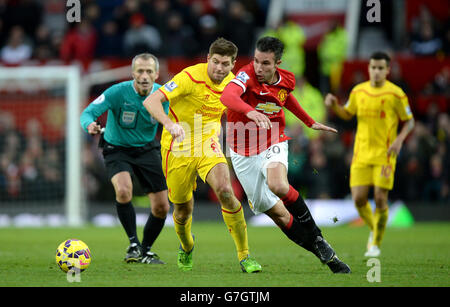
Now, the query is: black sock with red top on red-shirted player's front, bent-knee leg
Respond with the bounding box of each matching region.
[282,186,322,238]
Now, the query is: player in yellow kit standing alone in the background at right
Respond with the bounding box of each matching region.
[325,52,414,257]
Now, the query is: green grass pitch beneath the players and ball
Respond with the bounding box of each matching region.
[0,222,450,287]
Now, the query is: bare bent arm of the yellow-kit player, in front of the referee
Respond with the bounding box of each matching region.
[143,91,185,142]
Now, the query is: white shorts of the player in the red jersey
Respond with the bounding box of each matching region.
[230,141,288,214]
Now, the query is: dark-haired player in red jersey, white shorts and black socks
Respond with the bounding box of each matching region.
[221,37,350,273]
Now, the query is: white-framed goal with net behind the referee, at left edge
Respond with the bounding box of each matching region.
[0,66,82,226]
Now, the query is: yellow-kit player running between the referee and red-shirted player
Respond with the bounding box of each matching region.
[144,38,261,273]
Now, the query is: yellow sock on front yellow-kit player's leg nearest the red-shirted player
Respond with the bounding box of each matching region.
[222,206,248,261]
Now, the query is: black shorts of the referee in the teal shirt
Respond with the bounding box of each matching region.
[103,141,167,194]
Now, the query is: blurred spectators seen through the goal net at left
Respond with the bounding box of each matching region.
[0,110,65,201]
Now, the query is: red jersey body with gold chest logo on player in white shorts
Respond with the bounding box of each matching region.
[225,61,295,156]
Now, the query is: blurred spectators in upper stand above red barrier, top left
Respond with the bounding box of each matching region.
[0,0,270,64]
